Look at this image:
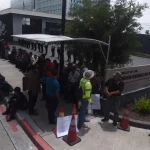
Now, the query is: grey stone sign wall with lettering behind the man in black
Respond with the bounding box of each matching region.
[106,65,150,94]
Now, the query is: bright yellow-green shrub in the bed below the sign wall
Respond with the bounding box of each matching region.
[133,96,150,114]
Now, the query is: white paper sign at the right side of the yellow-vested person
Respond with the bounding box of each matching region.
[91,94,101,110]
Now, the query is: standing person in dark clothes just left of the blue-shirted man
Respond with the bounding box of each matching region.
[27,66,40,115]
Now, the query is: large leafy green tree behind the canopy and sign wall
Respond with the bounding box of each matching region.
[66,0,147,72]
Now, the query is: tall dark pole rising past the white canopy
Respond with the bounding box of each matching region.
[59,0,66,75]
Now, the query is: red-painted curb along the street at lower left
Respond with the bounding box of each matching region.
[3,98,54,150]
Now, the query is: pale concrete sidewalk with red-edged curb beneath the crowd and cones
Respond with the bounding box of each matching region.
[0,53,150,150]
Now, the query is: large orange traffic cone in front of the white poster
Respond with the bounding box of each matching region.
[63,114,81,146]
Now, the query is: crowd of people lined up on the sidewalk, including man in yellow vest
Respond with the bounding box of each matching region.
[0,40,124,129]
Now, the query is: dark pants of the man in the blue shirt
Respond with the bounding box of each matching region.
[46,95,58,122]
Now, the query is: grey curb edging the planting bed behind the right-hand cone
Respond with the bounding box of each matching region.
[110,113,150,129]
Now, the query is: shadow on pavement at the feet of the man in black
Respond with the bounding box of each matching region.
[98,122,117,132]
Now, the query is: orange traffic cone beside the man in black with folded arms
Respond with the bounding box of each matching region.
[118,105,130,132]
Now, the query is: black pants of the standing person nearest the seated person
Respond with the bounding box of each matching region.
[29,93,38,113]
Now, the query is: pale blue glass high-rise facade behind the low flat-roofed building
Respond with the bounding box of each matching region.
[11,0,110,15]
